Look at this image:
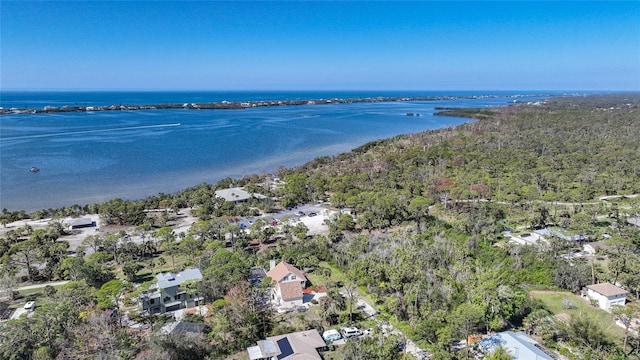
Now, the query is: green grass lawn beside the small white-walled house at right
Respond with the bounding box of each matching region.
[531,291,624,341]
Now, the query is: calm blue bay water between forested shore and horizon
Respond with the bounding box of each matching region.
[0,92,552,211]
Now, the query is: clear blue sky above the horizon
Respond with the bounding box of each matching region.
[0,0,640,91]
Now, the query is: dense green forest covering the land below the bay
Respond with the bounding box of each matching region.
[0,94,640,359]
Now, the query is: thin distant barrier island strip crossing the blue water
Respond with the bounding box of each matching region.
[0,94,548,115]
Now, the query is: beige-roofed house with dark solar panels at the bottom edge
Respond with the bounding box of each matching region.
[247,329,327,360]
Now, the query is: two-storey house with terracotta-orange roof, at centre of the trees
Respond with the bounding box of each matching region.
[267,260,307,308]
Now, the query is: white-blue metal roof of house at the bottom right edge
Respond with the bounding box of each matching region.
[477,331,555,360]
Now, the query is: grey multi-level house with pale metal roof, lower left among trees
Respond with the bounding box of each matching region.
[140,268,203,314]
